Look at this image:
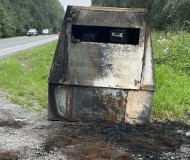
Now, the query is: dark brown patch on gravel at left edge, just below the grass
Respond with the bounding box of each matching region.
[0,120,26,129]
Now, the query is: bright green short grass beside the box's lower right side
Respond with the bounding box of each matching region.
[152,65,190,120]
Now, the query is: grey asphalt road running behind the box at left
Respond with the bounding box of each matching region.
[0,35,58,60]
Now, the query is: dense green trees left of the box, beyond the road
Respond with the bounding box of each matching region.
[0,0,64,38]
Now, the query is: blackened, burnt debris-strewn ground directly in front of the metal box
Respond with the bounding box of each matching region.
[43,121,190,160]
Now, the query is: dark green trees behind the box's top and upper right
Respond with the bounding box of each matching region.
[92,0,190,31]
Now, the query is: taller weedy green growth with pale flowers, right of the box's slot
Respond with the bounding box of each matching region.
[153,32,190,75]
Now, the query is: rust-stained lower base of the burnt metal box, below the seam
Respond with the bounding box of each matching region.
[48,84,154,125]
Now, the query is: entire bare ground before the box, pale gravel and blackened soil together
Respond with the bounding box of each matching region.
[0,92,190,160]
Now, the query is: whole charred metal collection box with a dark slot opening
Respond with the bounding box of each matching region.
[48,6,155,124]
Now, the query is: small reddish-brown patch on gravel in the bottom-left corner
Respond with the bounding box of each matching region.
[0,151,21,160]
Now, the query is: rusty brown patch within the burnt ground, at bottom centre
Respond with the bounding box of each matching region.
[64,141,134,160]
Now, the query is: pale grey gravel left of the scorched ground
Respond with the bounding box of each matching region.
[0,92,65,160]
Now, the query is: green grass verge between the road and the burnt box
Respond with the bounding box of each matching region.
[0,41,57,111]
